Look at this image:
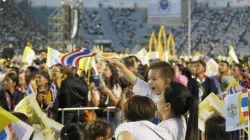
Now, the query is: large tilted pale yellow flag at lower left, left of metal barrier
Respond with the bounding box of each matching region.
[14,94,53,140]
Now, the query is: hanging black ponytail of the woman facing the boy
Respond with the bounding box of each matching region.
[185,96,199,140]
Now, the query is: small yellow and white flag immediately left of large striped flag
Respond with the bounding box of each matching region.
[46,47,61,67]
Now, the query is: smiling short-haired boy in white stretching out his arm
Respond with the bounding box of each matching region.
[111,60,175,103]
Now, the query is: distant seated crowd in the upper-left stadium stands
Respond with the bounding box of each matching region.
[0,2,47,49]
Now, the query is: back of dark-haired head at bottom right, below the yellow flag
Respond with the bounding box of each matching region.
[202,116,232,140]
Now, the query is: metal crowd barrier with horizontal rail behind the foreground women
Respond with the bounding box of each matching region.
[58,106,116,124]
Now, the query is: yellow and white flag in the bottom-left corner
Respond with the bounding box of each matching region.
[0,107,34,140]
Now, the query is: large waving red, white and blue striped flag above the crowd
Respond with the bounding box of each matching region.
[61,47,96,67]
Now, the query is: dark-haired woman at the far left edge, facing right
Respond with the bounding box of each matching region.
[0,73,24,111]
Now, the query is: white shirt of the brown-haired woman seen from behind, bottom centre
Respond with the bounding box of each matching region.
[115,121,174,140]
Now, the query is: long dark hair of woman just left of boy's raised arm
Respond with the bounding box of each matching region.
[107,64,120,89]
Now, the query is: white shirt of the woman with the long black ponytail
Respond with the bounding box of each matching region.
[157,116,187,140]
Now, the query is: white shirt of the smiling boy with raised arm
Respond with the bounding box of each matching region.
[133,78,159,104]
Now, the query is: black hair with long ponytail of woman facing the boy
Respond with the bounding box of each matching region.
[164,82,198,140]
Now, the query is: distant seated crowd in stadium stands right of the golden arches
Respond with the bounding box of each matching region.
[144,8,250,56]
